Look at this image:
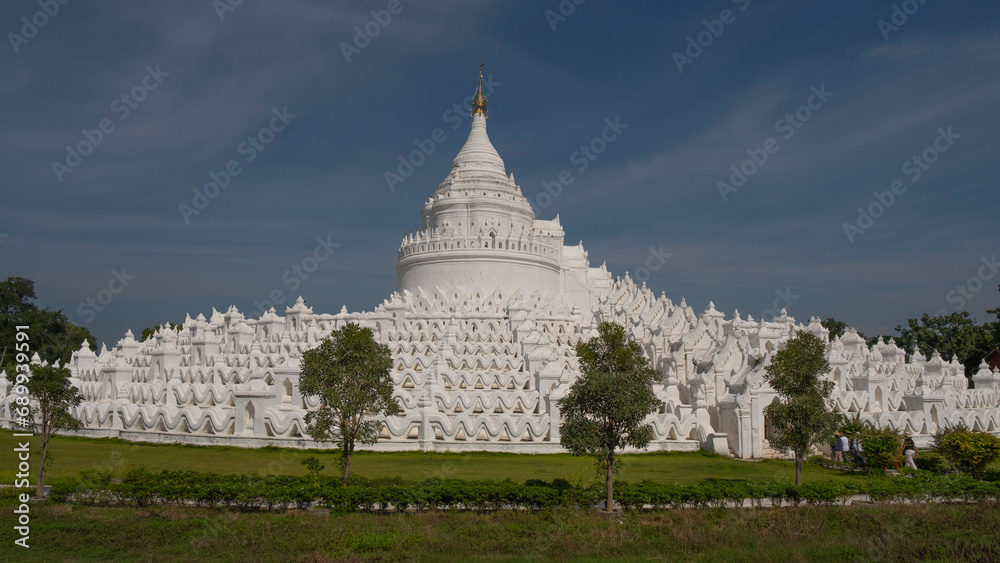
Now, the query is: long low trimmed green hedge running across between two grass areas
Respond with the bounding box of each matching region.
[52,469,1000,512]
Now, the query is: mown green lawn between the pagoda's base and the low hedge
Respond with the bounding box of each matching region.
[0,430,857,484]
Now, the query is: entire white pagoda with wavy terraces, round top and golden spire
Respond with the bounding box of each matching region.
[0,68,1000,458]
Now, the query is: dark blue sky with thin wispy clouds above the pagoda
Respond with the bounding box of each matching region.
[0,0,1000,345]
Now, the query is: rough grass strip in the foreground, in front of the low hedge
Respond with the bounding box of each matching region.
[0,500,1000,563]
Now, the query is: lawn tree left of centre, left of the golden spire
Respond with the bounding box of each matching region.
[299,323,401,485]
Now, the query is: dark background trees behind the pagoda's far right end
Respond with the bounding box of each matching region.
[896,316,1000,376]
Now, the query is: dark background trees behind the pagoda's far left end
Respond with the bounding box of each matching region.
[0,277,97,374]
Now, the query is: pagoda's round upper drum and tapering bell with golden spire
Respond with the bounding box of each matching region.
[396,70,610,311]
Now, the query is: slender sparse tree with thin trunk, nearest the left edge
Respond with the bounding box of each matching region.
[7,364,83,498]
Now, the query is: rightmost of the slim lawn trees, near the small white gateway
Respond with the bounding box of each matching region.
[764,331,841,486]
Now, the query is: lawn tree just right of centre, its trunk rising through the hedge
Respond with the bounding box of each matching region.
[559,322,663,512]
